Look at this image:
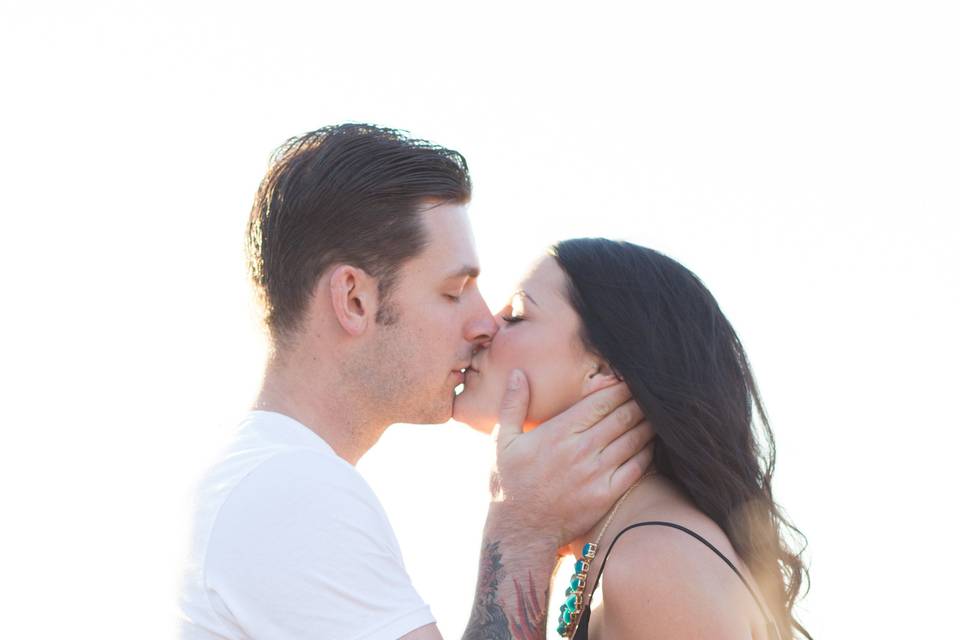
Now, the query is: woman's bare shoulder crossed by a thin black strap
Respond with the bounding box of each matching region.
[601,505,753,638]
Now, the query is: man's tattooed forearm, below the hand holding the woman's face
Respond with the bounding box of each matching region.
[463,503,557,640]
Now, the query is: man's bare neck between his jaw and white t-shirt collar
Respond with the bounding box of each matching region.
[253,356,389,465]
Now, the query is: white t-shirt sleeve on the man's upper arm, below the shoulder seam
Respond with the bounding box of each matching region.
[205,451,434,640]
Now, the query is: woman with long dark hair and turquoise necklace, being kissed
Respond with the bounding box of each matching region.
[454,239,811,640]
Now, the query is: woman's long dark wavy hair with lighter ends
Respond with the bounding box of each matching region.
[551,238,811,638]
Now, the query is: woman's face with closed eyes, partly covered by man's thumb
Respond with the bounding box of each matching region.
[453,256,606,431]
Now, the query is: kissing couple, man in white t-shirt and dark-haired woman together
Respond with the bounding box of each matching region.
[180,124,810,640]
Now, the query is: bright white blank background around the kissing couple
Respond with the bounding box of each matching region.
[0,0,960,638]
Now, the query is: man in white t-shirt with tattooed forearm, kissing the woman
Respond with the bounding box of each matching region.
[181,125,650,640]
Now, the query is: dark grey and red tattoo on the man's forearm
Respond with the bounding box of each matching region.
[463,541,546,640]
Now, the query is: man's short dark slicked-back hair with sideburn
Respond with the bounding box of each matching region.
[247,124,471,341]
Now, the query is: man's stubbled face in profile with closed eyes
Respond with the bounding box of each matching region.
[370,204,497,423]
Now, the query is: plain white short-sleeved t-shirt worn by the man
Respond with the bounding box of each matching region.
[180,411,434,640]
